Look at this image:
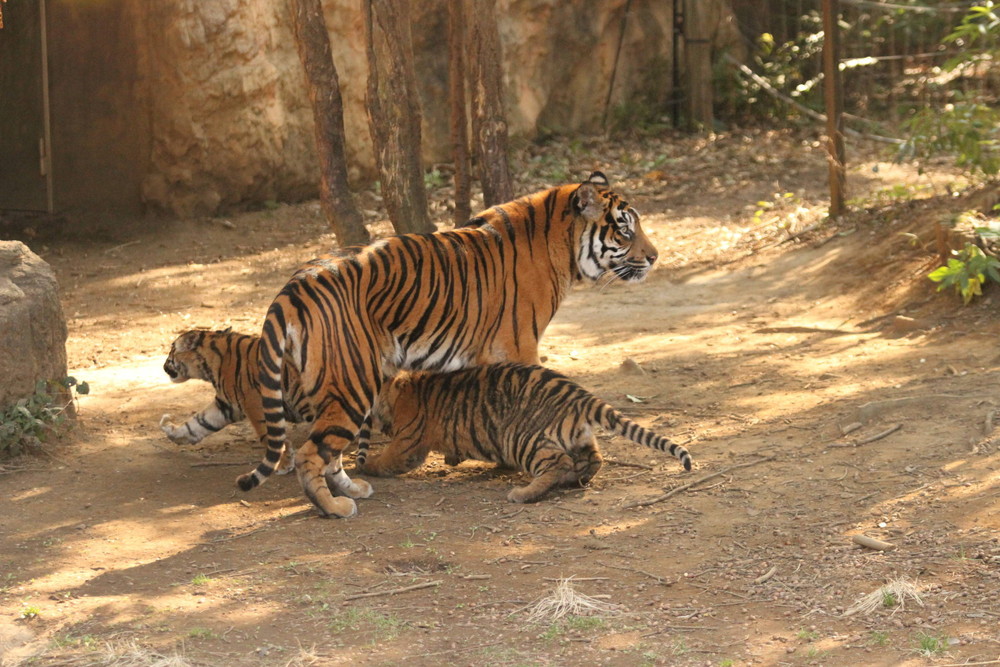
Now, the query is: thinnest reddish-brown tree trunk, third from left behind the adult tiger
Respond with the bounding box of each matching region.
[448,0,472,227]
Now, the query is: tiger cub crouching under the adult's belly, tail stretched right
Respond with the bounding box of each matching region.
[358,363,691,503]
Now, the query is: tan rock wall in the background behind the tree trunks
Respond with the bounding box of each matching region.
[126,0,724,215]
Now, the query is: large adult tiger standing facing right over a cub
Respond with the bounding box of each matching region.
[255,172,656,517]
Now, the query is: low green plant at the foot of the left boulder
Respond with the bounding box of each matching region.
[0,377,90,456]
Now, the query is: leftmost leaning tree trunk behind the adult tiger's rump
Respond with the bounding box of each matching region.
[291,0,371,246]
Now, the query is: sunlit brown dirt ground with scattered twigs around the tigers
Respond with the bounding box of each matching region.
[0,133,1000,667]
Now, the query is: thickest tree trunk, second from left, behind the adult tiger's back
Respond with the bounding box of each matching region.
[365,0,435,234]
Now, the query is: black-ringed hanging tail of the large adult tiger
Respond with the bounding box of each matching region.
[236,295,287,491]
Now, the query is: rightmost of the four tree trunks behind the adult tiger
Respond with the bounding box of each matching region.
[465,0,514,206]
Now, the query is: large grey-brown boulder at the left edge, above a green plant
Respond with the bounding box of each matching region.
[0,241,66,407]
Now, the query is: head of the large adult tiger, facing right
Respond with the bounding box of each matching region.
[570,171,657,282]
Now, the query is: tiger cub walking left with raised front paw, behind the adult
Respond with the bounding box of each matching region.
[160,329,312,489]
